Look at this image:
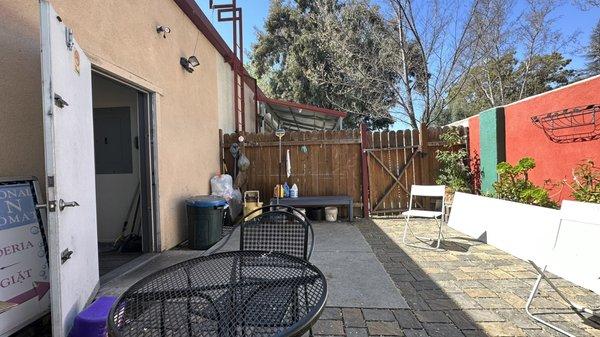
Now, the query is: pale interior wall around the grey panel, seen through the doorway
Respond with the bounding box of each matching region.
[92,74,140,242]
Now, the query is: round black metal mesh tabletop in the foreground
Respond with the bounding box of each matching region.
[108,251,327,337]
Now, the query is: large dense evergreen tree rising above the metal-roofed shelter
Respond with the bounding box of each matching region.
[251,0,395,128]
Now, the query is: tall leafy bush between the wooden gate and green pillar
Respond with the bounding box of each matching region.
[435,129,471,192]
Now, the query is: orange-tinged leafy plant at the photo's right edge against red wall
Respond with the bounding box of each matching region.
[570,159,600,204]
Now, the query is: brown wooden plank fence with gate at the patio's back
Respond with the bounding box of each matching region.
[220,124,468,216]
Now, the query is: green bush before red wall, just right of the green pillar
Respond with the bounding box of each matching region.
[494,157,558,208]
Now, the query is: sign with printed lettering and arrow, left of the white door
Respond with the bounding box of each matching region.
[0,182,50,336]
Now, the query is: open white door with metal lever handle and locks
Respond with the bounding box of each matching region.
[40,0,99,337]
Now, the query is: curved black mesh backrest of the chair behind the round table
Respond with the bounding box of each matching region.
[240,206,314,261]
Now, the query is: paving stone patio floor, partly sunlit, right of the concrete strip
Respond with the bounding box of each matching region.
[313,219,600,337]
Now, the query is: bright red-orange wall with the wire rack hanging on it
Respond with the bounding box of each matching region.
[504,76,600,200]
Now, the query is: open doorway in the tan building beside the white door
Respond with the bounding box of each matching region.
[92,72,153,278]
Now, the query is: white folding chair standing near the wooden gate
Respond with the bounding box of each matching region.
[402,185,446,250]
